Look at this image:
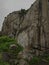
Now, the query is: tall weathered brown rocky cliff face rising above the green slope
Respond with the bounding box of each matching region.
[2,0,49,57]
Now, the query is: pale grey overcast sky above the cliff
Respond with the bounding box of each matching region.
[0,0,35,30]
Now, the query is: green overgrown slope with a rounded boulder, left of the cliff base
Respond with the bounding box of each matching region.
[0,36,23,65]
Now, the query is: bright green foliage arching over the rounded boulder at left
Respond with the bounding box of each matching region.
[0,36,22,52]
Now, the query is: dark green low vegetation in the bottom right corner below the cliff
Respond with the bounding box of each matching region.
[24,54,49,65]
